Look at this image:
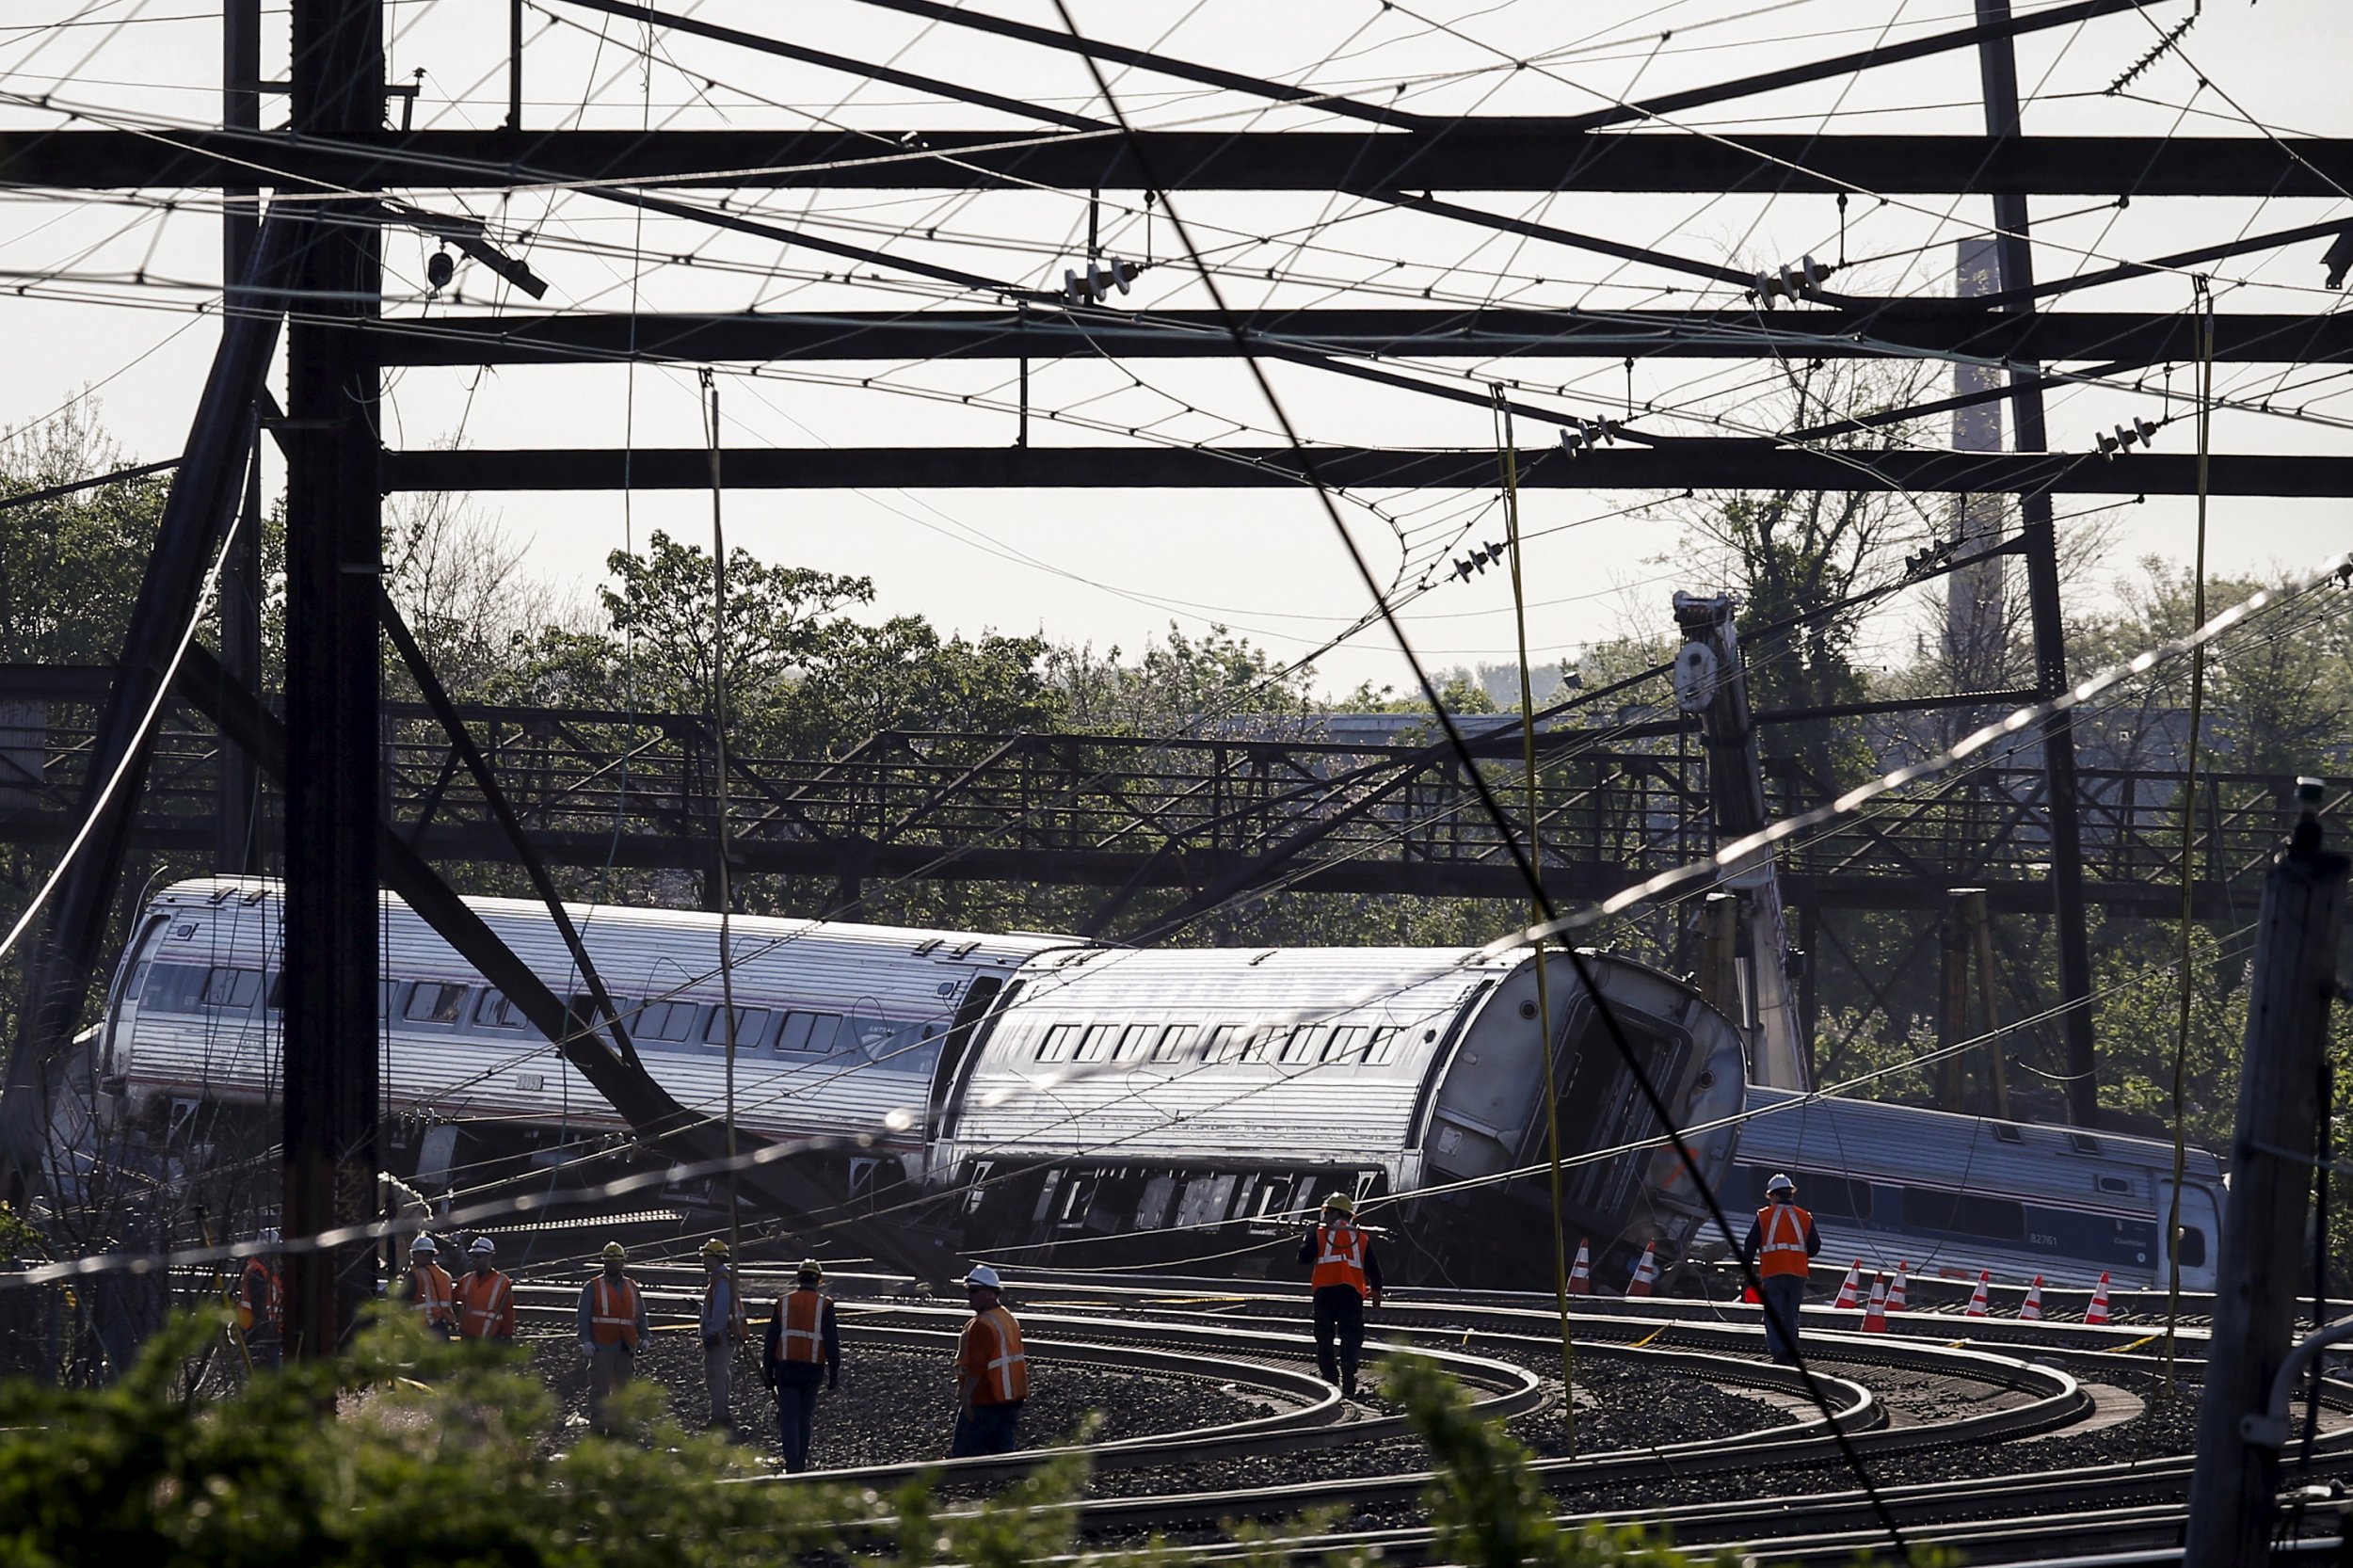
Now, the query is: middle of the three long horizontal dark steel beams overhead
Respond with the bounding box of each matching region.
[365,306,2353,370]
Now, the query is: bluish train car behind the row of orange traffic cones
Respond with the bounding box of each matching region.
[1711,1088,2224,1290]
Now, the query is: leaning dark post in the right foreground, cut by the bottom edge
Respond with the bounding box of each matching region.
[2184,779,2353,1568]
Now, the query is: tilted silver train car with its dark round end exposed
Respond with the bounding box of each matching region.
[935,949,1741,1286]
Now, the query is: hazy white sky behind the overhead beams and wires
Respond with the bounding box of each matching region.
[0,0,2353,687]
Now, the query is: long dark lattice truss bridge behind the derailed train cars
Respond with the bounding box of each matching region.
[0,668,2315,935]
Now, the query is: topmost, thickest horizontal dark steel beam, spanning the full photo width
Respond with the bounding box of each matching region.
[18,131,2353,196]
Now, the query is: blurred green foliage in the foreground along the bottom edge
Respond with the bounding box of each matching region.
[0,1314,1688,1568]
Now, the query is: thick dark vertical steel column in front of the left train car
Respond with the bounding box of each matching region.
[285,0,384,1358]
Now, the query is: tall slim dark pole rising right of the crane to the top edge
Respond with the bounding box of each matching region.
[1977,0,2099,1128]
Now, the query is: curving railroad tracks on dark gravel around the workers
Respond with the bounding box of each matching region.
[482,1264,2353,1560]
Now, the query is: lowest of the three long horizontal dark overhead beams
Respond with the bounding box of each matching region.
[381,440,2353,497]
